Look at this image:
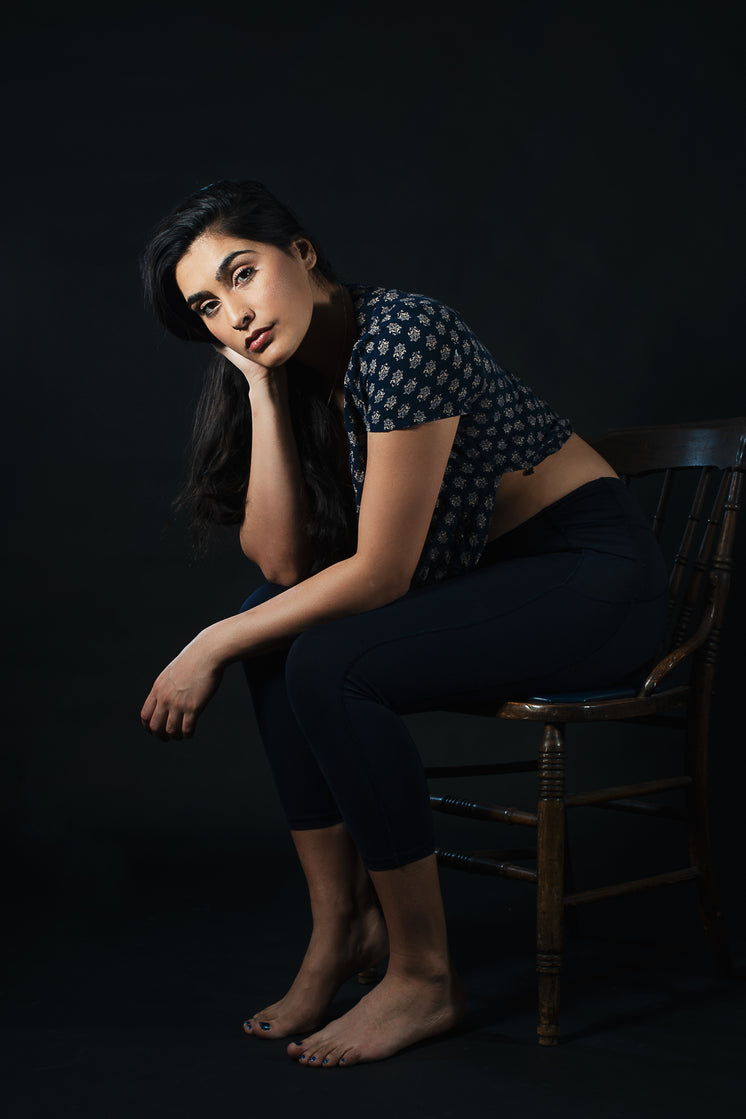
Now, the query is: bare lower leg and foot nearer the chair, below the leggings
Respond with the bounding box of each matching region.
[287,855,465,1068]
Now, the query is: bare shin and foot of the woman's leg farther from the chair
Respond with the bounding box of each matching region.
[244,824,388,1038]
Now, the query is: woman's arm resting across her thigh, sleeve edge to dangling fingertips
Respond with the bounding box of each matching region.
[141,416,460,741]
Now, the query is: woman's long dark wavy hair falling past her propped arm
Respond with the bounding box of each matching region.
[142,179,355,571]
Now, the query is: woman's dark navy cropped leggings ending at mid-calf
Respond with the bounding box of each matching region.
[242,478,667,871]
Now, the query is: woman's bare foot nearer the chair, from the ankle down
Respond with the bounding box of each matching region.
[287,970,465,1069]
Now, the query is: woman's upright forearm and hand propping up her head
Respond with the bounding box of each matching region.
[219,348,312,586]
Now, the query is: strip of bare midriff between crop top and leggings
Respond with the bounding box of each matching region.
[487,434,618,540]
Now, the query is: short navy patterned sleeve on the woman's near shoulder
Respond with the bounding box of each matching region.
[360,297,484,432]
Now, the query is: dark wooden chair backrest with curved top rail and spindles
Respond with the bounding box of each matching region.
[594,417,746,680]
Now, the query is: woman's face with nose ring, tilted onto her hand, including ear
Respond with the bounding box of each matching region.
[176,231,317,368]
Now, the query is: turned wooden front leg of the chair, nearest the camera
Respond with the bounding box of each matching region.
[536,723,565,1045]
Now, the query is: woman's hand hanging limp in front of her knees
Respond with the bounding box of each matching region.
[140,633,223,742]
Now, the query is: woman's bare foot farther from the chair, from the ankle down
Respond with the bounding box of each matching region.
[244,906,388,1038]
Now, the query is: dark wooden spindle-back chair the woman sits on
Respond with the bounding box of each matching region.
[426,419,746,1045]
